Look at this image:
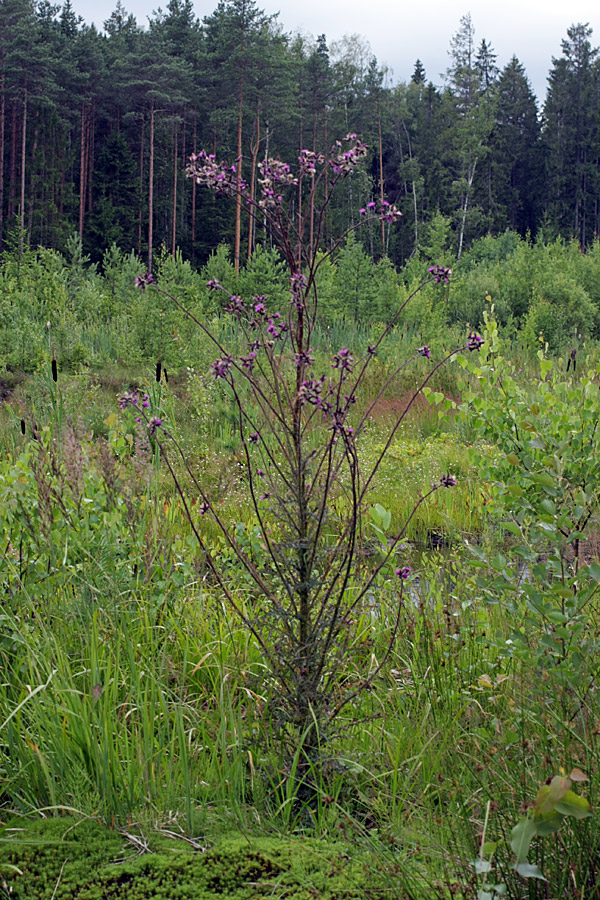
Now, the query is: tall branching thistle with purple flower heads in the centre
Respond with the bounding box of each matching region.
[127,135,482,761]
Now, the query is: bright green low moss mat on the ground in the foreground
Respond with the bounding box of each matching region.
[0,819,389,900]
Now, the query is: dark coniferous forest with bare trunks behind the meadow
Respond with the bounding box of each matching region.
[0,0,600,268]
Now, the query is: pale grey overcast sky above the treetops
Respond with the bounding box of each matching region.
[72,0,600,100]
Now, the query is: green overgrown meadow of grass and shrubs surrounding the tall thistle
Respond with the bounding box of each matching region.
[0,220,600,900]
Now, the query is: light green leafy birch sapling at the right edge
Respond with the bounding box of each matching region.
[464,312,600,702]
